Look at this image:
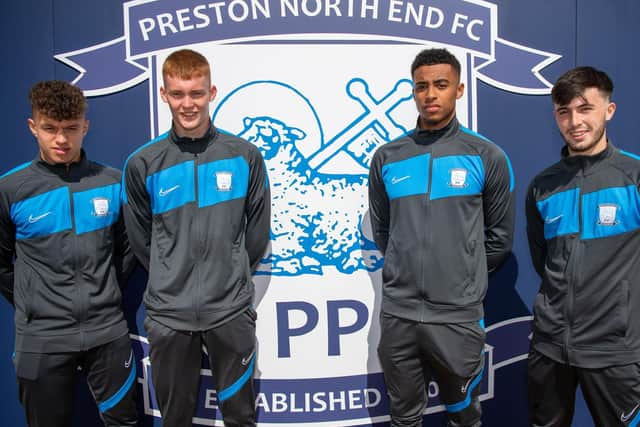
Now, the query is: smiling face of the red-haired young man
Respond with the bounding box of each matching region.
[160,74,217,138]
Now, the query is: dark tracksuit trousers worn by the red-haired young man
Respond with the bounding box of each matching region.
[144,309,256,427]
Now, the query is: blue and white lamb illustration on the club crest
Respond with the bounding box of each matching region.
[239,116,382,275]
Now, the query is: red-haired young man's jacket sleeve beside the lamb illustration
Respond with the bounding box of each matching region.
[245,147,271,272]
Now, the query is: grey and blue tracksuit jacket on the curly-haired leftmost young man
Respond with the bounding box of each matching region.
[0,152,135,353]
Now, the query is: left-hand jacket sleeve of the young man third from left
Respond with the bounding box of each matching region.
[369,151,389,255]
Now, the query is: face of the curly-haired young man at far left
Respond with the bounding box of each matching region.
[28,111,89,165]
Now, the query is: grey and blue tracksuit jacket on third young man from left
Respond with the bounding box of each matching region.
[369,118,514,323]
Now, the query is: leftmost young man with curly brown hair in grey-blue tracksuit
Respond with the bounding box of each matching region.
[0,81,137,427]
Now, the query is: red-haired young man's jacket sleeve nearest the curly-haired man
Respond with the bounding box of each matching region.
[122,158,152,272]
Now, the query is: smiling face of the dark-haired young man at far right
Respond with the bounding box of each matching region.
[554,87,616,156]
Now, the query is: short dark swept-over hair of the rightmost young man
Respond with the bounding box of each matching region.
[551,67,613,105]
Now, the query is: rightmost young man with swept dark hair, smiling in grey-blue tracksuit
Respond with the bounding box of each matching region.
[526,67,640,427]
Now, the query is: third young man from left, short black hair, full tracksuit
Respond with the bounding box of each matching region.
[369,49,514,427]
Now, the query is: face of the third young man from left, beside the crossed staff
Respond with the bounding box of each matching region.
[413,64,464,130]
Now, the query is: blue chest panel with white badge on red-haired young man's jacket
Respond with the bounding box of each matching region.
[198,157,249,208]
